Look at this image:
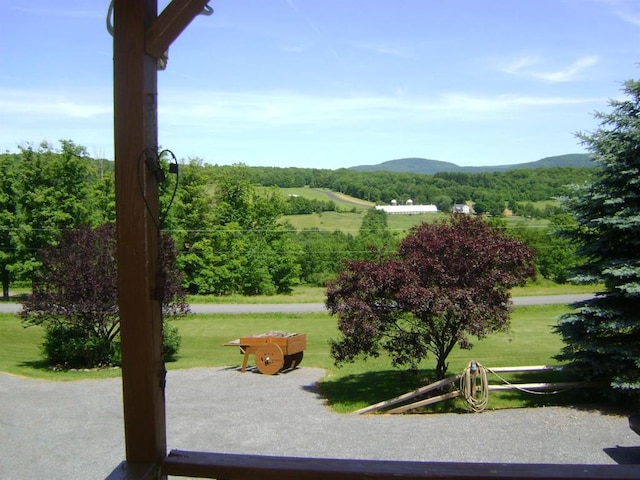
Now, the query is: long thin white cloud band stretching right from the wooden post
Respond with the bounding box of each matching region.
[159,92,606,130]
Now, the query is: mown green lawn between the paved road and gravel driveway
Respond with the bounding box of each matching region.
[0,305,592,412]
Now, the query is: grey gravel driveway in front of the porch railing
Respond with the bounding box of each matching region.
[0,367,640,480]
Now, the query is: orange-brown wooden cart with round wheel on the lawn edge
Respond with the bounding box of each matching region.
[224,332,307,375]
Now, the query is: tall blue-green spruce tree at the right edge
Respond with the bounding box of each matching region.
[557,80,640,392]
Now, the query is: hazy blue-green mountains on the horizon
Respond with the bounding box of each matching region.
[350,153,596,175]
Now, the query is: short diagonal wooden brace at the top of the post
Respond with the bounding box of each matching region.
[146,0,209,59]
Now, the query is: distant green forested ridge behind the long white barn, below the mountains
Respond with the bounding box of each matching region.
[219,166,595,216]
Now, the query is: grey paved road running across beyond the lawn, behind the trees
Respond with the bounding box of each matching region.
[0,294,593,313]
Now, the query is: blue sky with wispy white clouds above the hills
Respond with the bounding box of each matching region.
[0,0,640,169]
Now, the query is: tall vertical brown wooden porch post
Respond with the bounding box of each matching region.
[113,0,166,465]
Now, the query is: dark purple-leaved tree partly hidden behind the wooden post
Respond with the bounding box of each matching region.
[21,224,188,367]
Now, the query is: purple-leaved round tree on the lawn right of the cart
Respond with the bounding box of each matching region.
[326,215,535,379]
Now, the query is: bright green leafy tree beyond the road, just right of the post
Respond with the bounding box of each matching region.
[179,166,302,295]
